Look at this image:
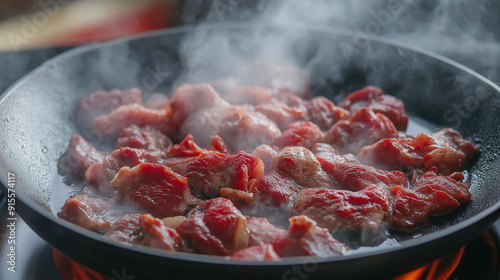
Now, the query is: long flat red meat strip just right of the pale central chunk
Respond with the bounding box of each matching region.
[319,158,406,191]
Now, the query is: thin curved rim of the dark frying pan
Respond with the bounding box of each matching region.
[0,22,500,266]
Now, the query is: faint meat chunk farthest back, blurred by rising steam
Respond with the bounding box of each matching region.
[240,61,311,98]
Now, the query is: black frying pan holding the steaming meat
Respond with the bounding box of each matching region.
[0,25,500,279]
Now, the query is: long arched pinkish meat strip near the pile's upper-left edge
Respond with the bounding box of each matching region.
[92,104,175,139]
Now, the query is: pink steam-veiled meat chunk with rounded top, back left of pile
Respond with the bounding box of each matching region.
[169,84,227,127]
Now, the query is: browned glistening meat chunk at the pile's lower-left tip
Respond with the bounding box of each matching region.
[57,194,115,233]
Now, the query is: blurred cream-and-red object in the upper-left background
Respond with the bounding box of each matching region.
[0,0,181,51]
